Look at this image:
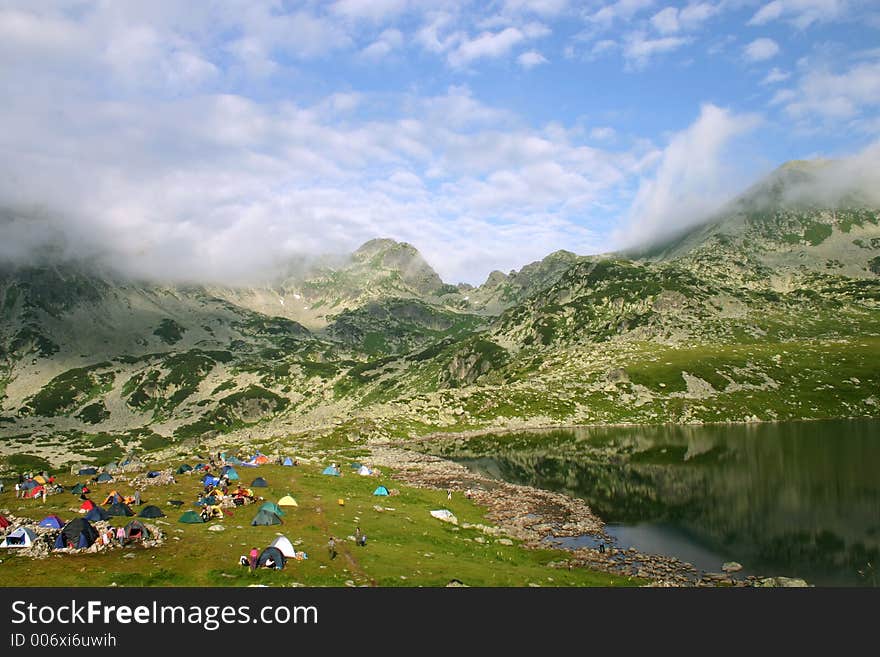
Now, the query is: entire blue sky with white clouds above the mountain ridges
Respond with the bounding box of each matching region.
[0,0,880,283]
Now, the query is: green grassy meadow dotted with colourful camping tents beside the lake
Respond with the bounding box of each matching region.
[0,449,641,587]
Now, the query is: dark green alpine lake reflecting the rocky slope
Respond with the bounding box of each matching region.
[431,419,880,586]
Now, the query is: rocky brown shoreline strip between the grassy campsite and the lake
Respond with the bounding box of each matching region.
[370,444,807,587]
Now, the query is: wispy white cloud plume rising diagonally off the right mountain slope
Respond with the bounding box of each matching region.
[616,104,760,247]
